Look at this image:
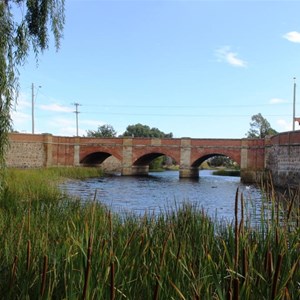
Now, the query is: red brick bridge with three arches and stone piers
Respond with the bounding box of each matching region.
[7,131,300,185]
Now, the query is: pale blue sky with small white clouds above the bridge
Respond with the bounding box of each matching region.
[12,0,300,138]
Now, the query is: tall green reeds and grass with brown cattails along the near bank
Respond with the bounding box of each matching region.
[0,169,300,299]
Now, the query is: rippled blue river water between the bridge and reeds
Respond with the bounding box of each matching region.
[61,171,260,220]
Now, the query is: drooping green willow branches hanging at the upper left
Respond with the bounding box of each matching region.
[0,0,65,168]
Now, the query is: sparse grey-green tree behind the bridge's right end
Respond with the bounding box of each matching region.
[246,113,278,138]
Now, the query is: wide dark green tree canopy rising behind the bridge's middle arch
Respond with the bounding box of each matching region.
[123,123,173,138]
